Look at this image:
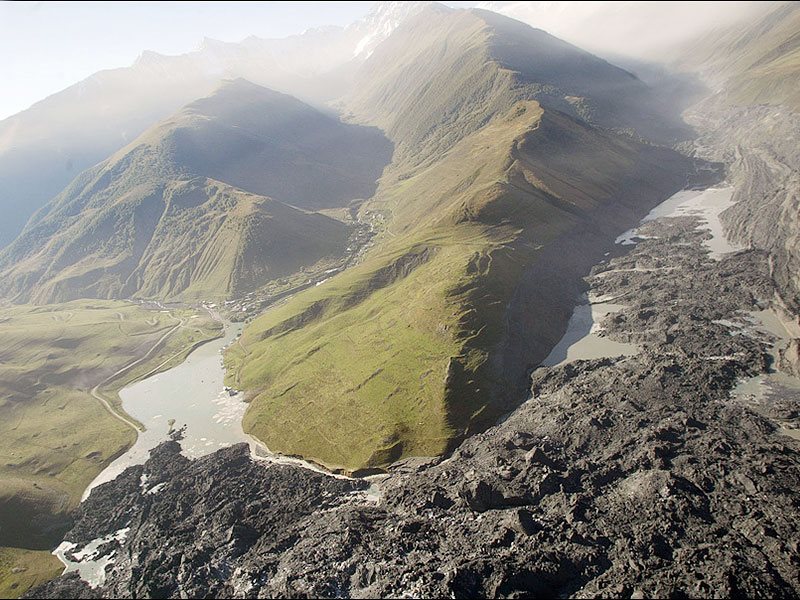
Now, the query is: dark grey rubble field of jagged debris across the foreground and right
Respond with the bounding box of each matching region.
[29,217,800,598]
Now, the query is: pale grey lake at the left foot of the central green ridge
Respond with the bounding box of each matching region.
[83,323,251,499]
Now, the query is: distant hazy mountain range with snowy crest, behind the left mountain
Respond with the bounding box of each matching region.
[0,2,427,248]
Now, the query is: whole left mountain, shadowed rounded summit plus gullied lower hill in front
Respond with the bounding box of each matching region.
[0,80,390,302]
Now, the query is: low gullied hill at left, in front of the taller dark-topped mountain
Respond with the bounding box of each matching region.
[3,178,349,303]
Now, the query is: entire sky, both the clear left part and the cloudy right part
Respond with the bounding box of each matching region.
[0,0,756,119]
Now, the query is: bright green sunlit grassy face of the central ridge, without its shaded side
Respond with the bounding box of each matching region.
[226,104,546,469]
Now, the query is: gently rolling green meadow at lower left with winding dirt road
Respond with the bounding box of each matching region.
[0,301,220,593]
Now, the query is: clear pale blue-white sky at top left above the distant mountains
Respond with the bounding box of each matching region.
[0,2,440,119]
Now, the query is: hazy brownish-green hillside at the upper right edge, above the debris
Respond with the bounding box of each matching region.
[680,2,800,313]
